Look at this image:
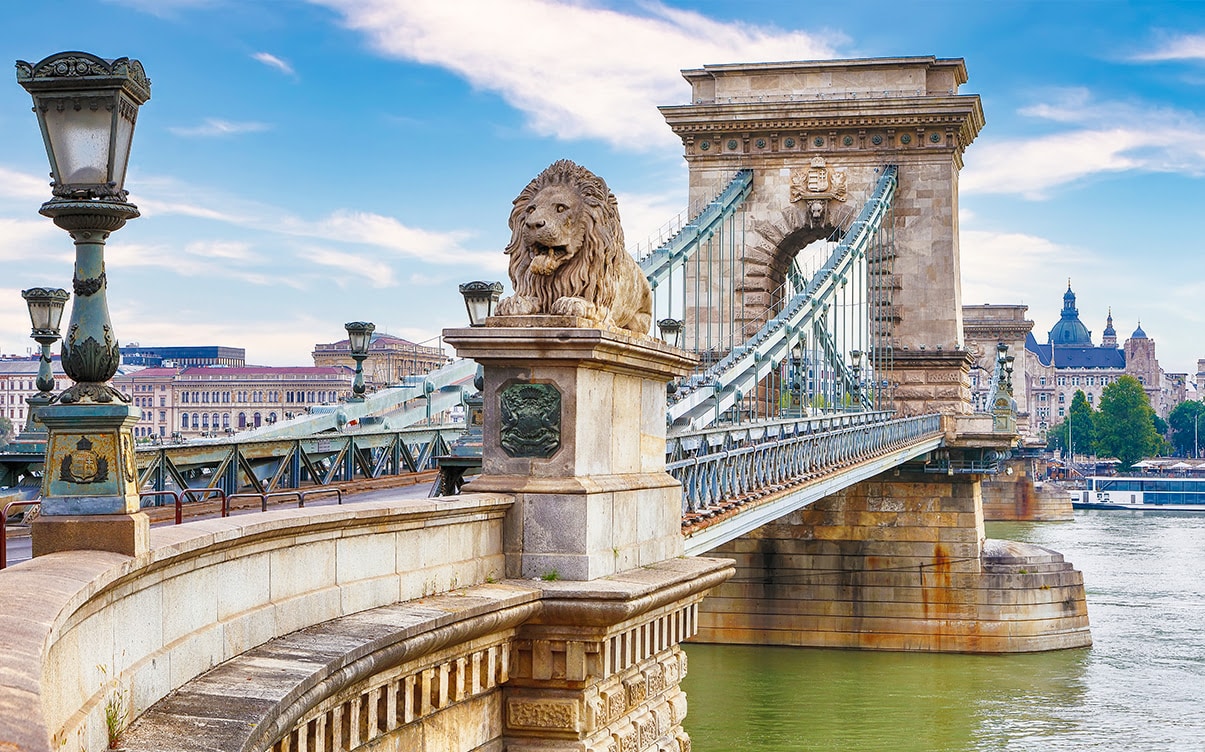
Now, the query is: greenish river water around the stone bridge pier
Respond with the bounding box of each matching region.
[683,511,1205,752]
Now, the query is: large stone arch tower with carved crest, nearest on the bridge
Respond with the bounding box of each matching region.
[662,57,983,413]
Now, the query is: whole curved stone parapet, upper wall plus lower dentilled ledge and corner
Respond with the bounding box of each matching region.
[0,494,731,752]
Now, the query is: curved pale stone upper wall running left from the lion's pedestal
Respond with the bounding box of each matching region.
[0,494,511,752]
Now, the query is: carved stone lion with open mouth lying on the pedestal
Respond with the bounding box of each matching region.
[496,159,653,334]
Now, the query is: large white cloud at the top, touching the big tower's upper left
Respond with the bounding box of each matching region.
[310,0,844,151]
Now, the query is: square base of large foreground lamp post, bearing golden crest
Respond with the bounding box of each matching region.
[30,404,149,556]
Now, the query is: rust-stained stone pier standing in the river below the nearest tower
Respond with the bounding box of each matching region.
[698,471,1091,653]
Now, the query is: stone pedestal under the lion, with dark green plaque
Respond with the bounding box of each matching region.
[443,316,693,580]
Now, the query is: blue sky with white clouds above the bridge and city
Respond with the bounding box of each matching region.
[0,0,1205,374]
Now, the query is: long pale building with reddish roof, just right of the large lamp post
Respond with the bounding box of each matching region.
[113,366,354,439]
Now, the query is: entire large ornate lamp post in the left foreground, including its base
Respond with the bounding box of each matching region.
[17,52,151,556]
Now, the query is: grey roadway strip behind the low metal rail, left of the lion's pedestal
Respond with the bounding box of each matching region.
[5,471,435,566]
